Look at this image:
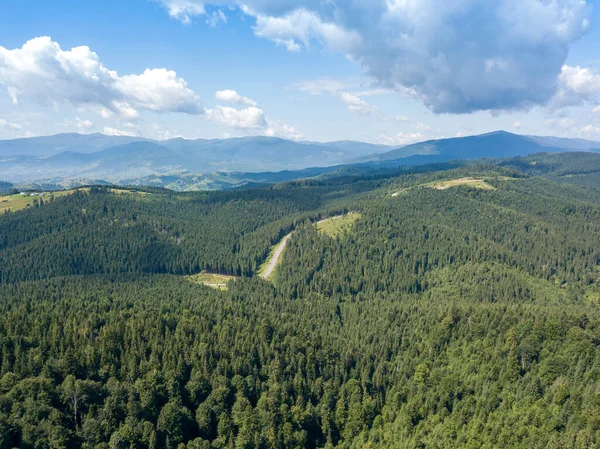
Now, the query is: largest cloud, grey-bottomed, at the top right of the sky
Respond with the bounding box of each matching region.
[166,0,592,113]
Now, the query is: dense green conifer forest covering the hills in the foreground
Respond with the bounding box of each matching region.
[0,154,600,449]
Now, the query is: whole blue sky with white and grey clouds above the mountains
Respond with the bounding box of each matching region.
[0,0,600,145]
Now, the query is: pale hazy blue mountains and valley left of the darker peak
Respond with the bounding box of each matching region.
[0,134,390,187]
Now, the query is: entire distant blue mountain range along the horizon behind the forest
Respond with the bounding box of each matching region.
[0,131,600,190]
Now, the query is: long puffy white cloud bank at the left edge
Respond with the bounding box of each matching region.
[0,37,204,119]
